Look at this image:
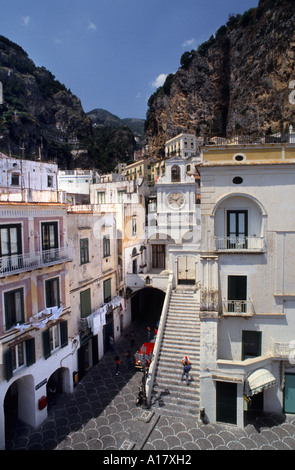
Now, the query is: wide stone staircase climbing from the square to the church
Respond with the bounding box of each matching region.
[151,289,200,417]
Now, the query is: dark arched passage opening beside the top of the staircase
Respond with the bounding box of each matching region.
[131,287,165,323]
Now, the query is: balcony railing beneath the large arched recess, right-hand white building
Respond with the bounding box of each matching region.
[215,237,265,252]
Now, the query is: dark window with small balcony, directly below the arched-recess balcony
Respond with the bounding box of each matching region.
[227,276,247,313]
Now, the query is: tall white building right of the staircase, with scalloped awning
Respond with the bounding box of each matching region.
[199,144,295,426]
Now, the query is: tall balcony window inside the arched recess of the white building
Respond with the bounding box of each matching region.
[227,210,248,249]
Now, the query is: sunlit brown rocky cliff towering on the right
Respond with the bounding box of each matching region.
[145,0,295,156]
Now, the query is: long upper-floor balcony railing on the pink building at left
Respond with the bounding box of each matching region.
[0,247,70,277]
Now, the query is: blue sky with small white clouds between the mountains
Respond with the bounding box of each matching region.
[0,0,258,119]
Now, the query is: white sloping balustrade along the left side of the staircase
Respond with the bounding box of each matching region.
[146,274,173,406]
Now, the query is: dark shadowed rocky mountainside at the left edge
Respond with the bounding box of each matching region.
[0,36,92,166]
